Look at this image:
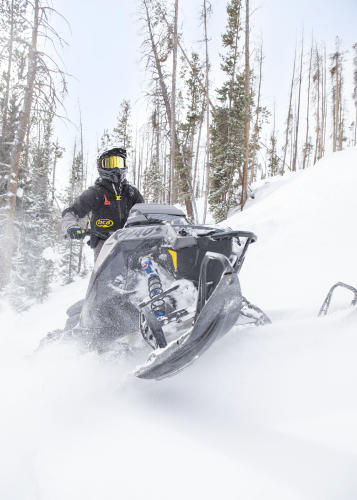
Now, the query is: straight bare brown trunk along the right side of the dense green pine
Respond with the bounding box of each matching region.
[241,0,250,210]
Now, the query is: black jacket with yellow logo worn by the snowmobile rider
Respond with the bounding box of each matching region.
[62,178,144,248]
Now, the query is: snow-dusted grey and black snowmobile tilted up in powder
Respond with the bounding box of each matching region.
[49,204,270,379]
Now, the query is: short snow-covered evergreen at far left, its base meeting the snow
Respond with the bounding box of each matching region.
[8,109,60,310]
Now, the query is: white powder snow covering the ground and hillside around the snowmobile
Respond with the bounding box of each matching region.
[0,149,357,500]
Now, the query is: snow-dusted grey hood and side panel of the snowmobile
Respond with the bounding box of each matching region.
[80,223,232,336]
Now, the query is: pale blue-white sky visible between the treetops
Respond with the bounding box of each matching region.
[53,0,357,187]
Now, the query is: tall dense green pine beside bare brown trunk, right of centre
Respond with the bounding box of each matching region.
[209,0,253,220]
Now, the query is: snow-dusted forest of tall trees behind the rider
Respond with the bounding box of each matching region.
[0,0,357,310]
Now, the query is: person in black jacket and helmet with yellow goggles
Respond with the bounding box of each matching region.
[62,148,144,261]
